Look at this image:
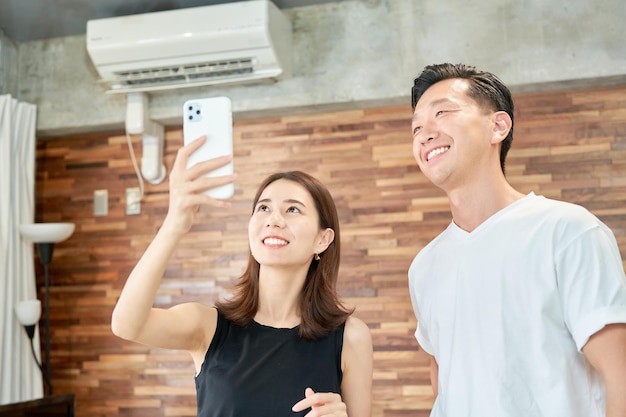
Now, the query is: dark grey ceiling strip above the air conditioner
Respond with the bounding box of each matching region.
[0,0,338,42]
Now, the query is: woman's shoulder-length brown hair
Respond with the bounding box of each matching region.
[216,171,353,340]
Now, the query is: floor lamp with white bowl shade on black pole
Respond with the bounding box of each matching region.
[20,223,74,395]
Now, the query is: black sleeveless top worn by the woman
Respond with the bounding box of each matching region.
[195,311,345,417]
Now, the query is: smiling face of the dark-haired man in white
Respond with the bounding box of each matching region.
[411,78,497,192]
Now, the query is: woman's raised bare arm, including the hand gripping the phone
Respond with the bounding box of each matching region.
[111,137,234,352]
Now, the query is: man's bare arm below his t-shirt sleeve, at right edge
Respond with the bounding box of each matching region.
[582,323,626,417]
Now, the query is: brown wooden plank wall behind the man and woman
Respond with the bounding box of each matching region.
[36,86,626,417]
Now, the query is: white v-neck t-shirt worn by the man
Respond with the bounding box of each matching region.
[409,193,626,417]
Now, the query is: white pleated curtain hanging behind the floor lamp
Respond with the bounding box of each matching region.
[0,95,43,404]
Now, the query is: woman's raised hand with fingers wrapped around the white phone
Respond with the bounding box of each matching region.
[163,136,235,234]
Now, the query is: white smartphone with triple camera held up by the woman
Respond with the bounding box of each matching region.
[183,97,235,199]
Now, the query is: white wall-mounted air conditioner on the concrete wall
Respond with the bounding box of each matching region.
[86,0,291,93]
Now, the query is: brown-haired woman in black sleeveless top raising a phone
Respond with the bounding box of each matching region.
[112,137,373,417]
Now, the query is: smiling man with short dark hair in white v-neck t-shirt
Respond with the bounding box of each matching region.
[409,64,626,417]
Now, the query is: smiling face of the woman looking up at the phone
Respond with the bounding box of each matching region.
[248,179,334,268]
